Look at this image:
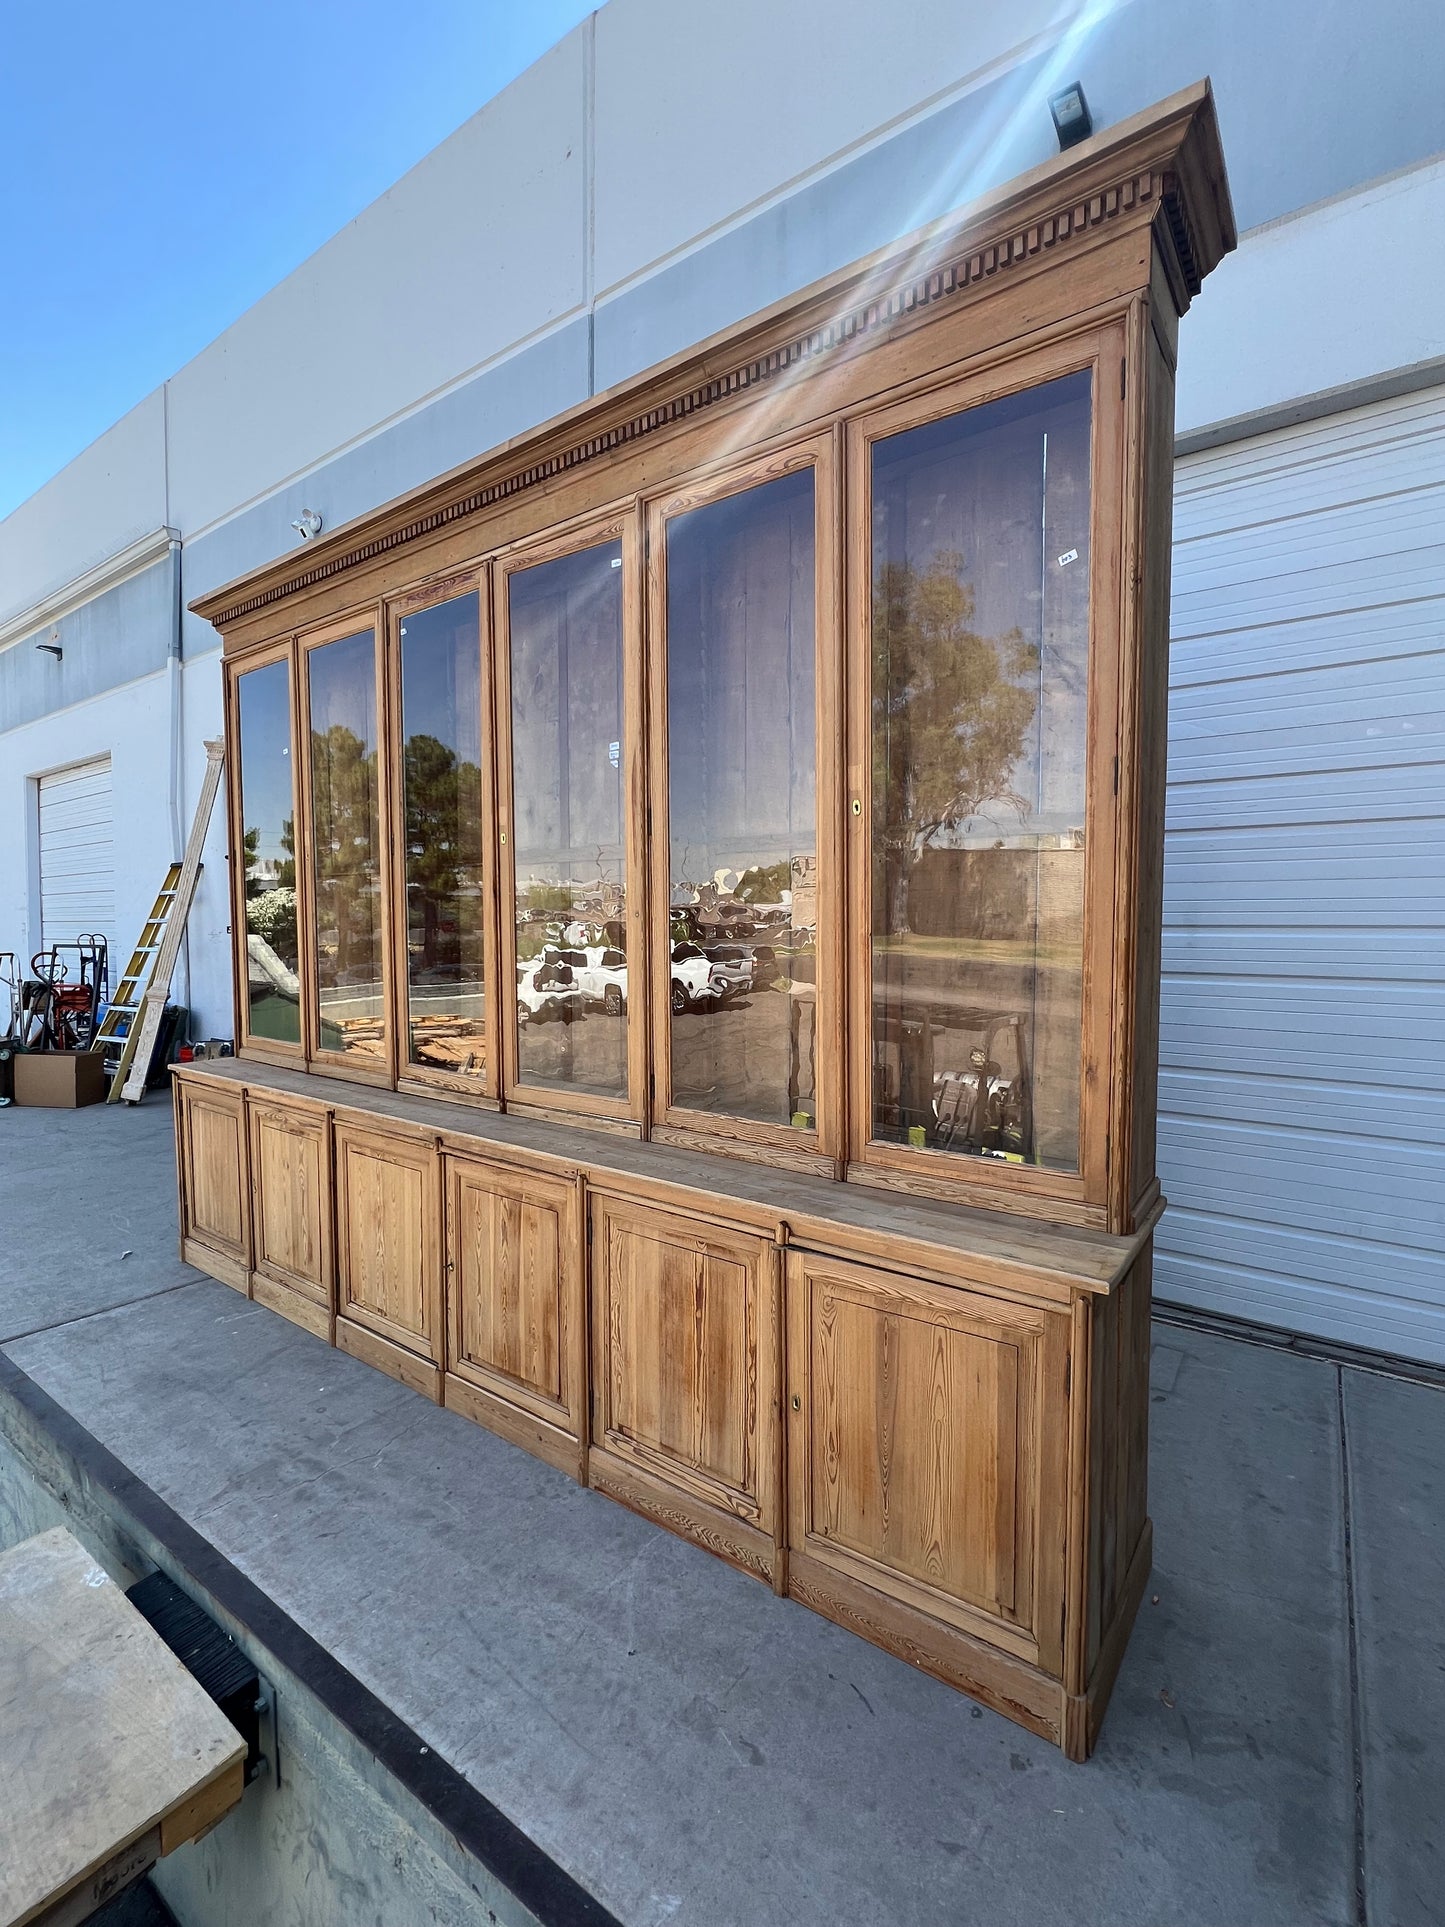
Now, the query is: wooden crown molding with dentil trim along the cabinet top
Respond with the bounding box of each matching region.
[191,81,1235,630]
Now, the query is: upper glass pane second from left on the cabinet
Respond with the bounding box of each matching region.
[306,628,387,1068]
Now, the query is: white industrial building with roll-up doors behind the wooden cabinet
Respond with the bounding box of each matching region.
[0,0,1445,1362]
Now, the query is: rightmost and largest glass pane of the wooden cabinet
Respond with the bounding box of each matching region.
[873,374,1089,1172]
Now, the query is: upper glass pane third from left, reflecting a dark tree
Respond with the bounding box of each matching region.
[401,594,486,1075]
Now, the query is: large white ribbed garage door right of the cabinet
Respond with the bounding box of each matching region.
[1156,389,1445,1362]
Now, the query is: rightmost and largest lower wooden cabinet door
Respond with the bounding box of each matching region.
[788,1251,1069,1675]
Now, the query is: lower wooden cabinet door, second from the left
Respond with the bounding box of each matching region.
[247,1098,335,1339]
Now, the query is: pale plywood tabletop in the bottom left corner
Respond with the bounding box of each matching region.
[0,1528,247,1927]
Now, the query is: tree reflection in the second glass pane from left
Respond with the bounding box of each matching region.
[310,723,378,985]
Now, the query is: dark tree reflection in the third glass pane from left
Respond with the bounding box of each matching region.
[403,736,482,969]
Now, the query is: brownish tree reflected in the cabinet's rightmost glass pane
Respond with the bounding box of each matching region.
[873,549,1038,933]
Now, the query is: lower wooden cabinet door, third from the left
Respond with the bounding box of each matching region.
[335,1118,441,1397]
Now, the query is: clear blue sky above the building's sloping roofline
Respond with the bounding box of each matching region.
[0,0,591,516]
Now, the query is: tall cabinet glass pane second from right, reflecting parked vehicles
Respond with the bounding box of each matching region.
[667,468,817,1129]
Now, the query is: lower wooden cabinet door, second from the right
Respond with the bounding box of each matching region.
[588,1195,780,1580]
